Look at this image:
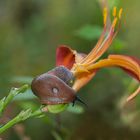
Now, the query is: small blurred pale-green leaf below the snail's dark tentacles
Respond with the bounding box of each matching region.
[67,105,84,114]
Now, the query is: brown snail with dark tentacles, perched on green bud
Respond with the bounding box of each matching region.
[31,66,85,105]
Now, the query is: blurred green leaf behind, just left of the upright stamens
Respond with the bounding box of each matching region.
[74,25,102,41]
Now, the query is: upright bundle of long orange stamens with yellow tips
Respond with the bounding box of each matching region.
[81,9,122,64]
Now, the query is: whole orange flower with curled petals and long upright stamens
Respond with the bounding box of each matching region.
[56,7,140,101]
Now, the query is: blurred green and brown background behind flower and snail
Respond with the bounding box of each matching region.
[0,0,140,140]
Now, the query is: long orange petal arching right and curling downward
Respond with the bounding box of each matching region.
[87,55,140,81]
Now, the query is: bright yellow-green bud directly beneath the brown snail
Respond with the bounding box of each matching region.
[47,104,68,113]
